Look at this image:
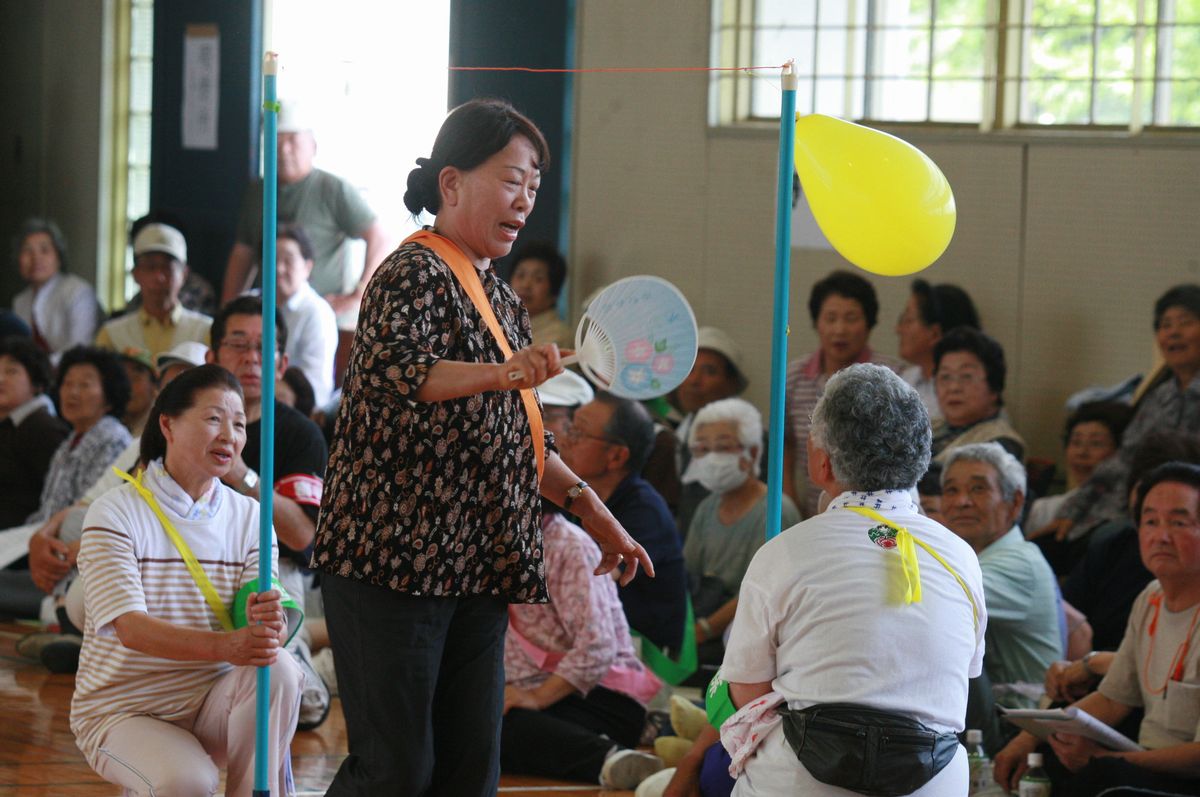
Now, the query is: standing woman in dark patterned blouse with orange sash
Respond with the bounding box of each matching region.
[313,101,653,796]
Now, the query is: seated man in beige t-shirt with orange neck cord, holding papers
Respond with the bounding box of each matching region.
[995,462,1200,797]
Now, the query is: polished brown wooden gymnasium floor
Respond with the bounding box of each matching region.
[0,623,632,797]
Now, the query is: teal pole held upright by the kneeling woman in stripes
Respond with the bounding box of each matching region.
[254,53,279,797]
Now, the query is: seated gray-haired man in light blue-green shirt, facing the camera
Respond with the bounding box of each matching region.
[942,443,1063,750]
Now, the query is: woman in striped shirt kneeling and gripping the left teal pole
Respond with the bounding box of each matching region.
[71,365,301,796]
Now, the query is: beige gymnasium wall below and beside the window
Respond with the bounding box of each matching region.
[570,0,1200,459]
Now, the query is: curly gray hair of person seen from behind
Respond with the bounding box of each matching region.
[809,362,934,491]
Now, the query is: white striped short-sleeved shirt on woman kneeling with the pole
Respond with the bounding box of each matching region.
[71,467,278,761]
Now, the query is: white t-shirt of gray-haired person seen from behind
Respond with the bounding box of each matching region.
[722,491,986,797]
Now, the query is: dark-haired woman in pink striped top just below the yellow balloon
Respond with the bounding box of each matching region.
[784,271,899,517]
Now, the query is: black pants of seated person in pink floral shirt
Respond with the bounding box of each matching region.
[500,687,646,784]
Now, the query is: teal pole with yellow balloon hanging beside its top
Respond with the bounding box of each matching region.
[767,61,804,540]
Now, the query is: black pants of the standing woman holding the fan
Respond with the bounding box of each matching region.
[322,575,508,797]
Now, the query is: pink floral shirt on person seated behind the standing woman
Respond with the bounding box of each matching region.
[504,515,642,695]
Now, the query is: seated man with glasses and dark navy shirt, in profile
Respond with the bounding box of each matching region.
[559,392,688,658]
